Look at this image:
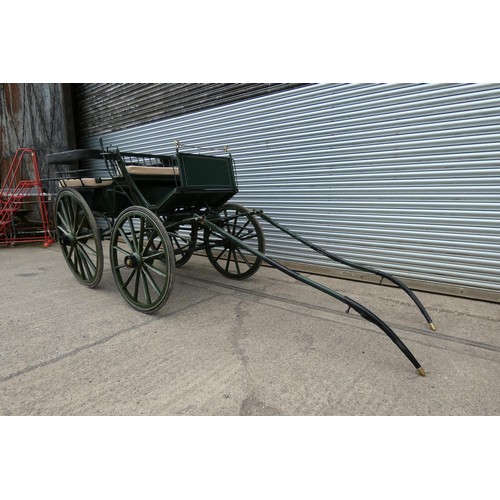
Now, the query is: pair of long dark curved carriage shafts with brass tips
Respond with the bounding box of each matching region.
[192,210,436,376]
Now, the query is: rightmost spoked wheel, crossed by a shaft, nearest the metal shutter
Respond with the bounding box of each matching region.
[204,203,265,280]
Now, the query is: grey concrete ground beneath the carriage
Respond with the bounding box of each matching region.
[0,245,500,416]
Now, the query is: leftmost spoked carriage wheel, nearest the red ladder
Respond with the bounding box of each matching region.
[55,188,104,288]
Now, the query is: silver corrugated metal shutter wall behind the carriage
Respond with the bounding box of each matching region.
[77,84,500,301]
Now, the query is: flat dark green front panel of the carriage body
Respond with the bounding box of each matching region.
[178,153,237,192]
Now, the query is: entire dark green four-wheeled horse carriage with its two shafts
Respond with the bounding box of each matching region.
[48,141,435,376]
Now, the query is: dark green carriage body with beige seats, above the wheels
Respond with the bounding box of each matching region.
[48,149,238,217]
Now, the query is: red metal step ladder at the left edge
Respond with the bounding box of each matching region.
[0,148,54,247]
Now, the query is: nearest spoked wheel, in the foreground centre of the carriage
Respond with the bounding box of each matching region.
[110,207,175,313]
